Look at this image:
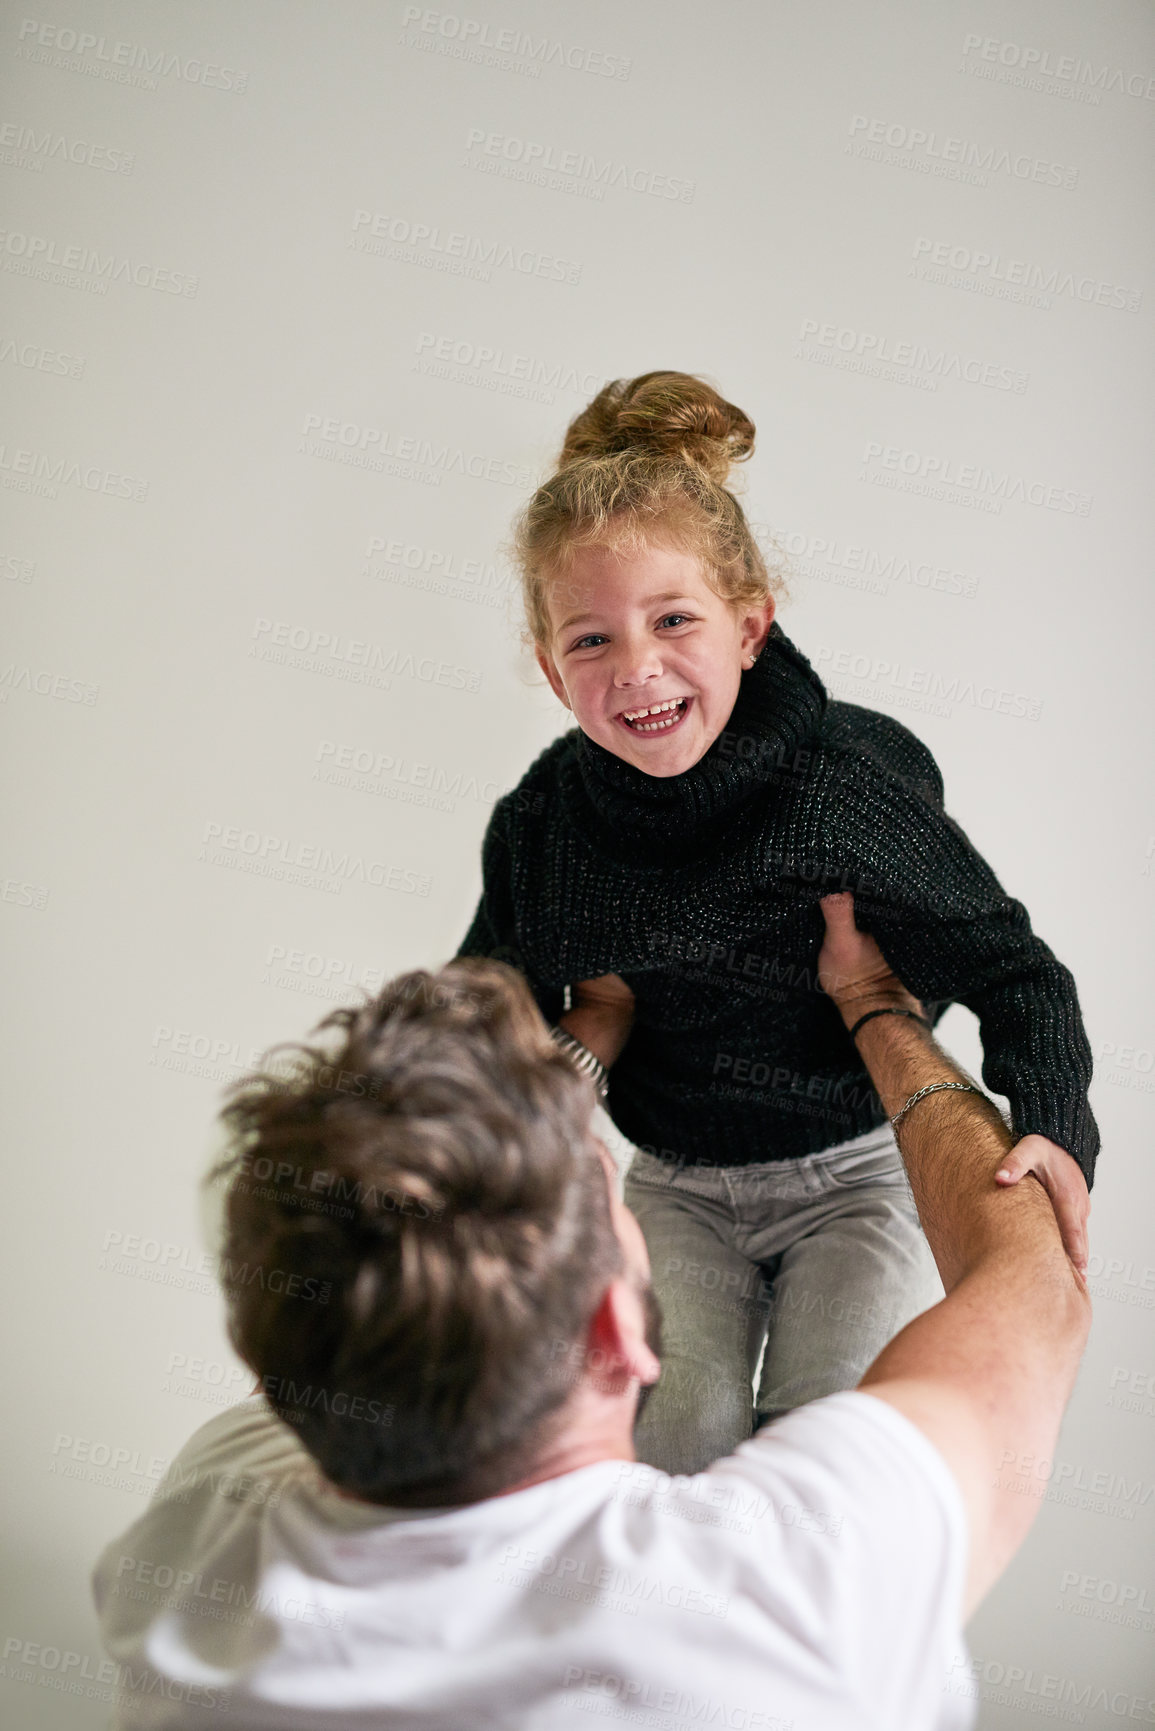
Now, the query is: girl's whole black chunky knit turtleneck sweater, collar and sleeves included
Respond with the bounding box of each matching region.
[459,625,1100,1184]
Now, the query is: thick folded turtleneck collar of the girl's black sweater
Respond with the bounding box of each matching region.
[566,623,828,859]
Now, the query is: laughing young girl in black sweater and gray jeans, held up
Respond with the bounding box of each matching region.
[459,372,1098,1471]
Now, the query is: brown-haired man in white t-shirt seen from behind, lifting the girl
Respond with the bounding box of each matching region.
[95,897,1089,1731]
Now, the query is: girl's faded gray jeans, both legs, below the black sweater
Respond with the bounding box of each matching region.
[625,1125,944,1473]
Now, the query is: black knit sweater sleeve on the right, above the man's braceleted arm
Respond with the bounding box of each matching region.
[855,729,1100,1187]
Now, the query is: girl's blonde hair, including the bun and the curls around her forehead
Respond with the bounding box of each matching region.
[511,372,783,644]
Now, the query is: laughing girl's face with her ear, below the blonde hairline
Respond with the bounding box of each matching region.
[537,547,774,775]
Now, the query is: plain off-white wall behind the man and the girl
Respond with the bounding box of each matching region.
[0,0,1155,1728]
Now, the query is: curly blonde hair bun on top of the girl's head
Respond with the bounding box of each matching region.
[559,372,753,486]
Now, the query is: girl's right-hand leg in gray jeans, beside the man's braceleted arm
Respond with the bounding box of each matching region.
[757,1130,944,1425]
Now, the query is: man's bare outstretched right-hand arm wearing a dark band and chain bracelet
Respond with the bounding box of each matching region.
[819,897,1091,1615]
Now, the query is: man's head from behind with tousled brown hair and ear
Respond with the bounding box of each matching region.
[208,959,656,1506]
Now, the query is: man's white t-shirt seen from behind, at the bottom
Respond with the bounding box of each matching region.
[94,1390,975,1731]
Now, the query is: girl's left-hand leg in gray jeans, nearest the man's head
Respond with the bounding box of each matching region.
[625,1153,769,1473]
